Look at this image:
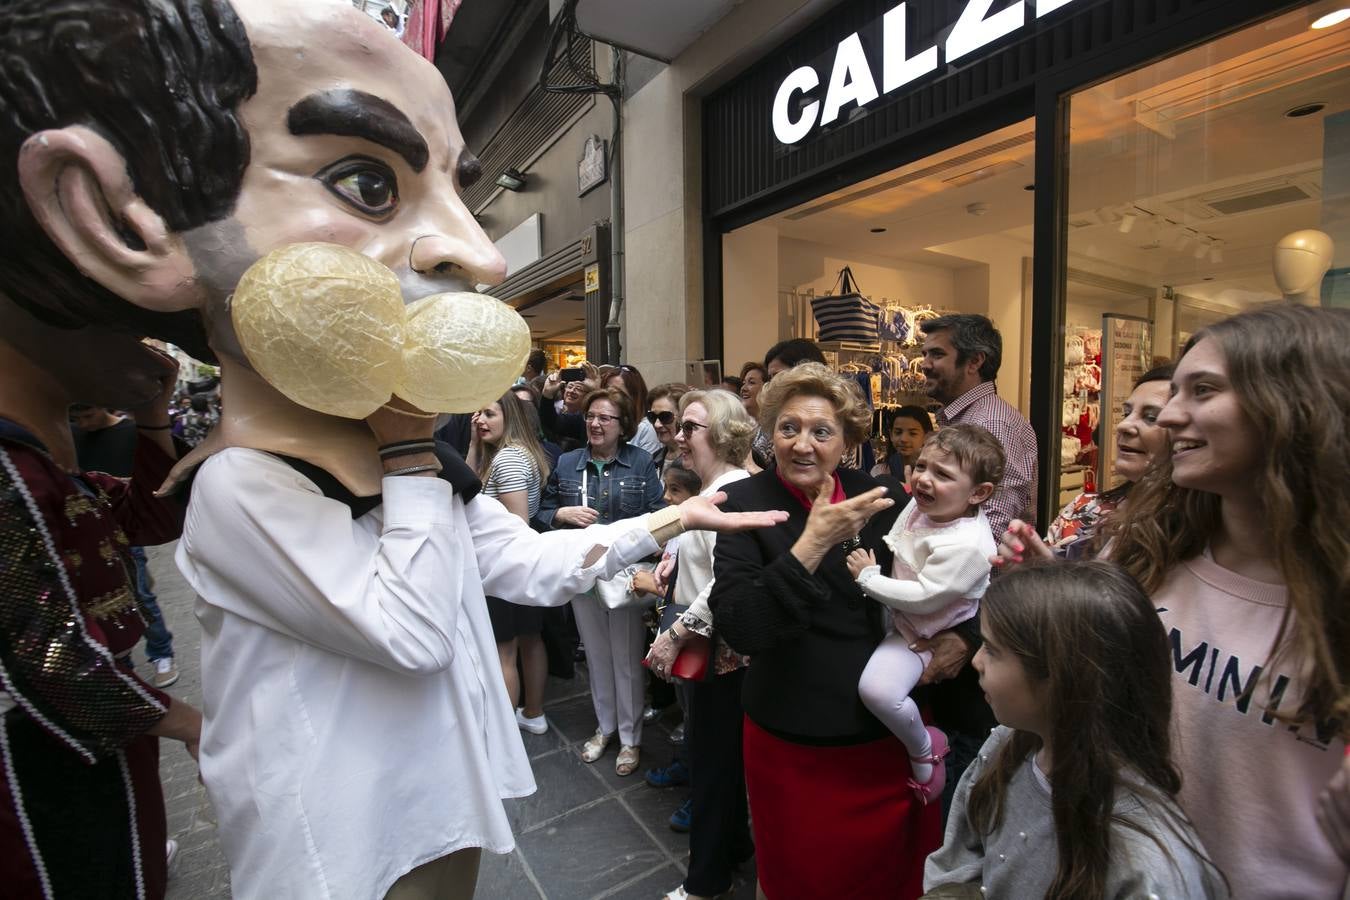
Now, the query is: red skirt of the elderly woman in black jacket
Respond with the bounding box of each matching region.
[744,716,942,900]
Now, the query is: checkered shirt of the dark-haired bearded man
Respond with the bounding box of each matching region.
[937,382,1037,541]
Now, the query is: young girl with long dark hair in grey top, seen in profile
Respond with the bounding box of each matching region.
[923,563,1227,900]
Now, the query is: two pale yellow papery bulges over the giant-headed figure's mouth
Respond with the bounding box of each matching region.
[230,243,529,418]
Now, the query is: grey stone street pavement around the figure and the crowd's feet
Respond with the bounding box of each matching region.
[150,545,755,900]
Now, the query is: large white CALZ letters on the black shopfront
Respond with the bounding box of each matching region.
[774,0,1075,144]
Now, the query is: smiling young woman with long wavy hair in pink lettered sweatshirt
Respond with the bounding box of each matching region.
[1107,304,1350,900]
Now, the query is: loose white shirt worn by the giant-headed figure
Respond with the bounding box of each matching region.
[177,448,657,900]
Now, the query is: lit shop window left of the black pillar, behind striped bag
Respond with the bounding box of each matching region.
[722,120,1034,450]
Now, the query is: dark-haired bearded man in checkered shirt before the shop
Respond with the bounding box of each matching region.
[919,316,1037,541]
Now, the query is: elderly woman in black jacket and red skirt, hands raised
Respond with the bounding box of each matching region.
[709,363,941,900]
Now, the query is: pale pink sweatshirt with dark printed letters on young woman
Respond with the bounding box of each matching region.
[1153,556,1347,900]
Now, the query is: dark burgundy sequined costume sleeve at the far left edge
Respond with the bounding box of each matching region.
[0,443,169,764]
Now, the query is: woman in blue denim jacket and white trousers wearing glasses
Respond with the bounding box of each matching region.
[537,389,666,775]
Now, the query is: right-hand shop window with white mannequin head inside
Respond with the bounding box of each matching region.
[1058,3,1350,501]
